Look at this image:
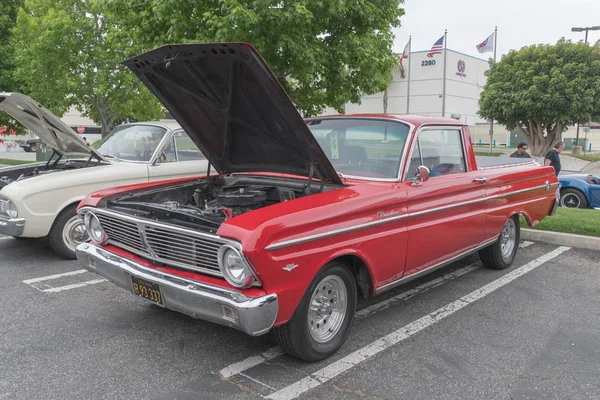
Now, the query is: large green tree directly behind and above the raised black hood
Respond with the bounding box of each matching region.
[101,0,404,115]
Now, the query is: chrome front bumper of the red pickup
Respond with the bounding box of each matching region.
[76,243,279,336]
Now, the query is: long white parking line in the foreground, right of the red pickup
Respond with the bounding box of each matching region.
[266,247,570,400]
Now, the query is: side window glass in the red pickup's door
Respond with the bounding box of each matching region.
[406,129,467,179]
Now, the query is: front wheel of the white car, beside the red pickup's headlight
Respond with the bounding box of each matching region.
[48,205,89,260]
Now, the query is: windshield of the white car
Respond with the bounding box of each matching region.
[98,125,167,162]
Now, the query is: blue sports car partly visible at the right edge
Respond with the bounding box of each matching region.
[558,174,600,210]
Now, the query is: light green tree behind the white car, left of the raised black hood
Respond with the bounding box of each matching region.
[13,0,164,136]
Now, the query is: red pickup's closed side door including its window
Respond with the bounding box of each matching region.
[403,126,486,276]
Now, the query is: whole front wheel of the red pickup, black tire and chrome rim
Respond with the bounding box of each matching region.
[274,262,358,362]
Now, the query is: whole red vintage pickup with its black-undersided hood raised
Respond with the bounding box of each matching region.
[77,43,558,361]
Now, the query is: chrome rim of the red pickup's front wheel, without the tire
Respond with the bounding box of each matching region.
[308,275,348,343]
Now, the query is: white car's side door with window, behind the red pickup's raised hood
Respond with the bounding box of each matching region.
[148,130,208,181]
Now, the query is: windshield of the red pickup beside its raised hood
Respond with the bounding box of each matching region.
[307,118,409,179]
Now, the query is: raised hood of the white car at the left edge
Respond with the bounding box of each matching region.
[0,93,106,161]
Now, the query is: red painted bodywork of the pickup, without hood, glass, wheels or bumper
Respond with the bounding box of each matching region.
[79,114,557,326]
